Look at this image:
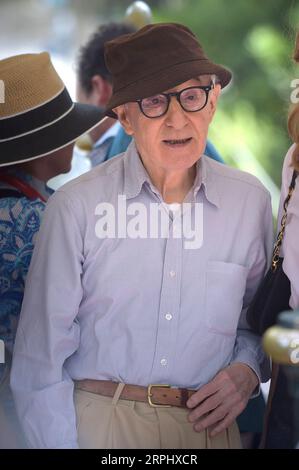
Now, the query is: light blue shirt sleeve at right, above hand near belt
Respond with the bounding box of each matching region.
[231,190,273,382]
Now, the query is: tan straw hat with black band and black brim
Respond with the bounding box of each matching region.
[0,52,103,167]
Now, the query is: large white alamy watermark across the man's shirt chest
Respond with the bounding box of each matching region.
[95,194,203,250]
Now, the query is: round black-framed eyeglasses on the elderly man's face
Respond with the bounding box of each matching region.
[136,82,215,118]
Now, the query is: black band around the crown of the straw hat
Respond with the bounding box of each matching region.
[0,88,73,141]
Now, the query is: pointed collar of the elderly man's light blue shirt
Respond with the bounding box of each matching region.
[124,140,220,208]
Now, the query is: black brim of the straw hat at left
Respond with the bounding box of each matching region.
[0,103,104,167]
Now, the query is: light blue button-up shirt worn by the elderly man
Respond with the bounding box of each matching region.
[11,142,272,448]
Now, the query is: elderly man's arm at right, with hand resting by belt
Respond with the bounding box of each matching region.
[187,189,273,436]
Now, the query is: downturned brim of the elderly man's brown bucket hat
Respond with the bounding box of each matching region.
[106,59,232,119]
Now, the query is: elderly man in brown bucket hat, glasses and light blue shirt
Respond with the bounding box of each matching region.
[12,23,272,448]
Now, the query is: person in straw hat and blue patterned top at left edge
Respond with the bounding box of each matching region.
[0,52,102,448]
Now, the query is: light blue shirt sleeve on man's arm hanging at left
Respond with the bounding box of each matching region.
[11,191,83,448]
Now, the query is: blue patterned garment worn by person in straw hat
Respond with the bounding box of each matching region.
[0,169,53,449]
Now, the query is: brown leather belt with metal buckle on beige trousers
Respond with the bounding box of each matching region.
[75,379,196,408]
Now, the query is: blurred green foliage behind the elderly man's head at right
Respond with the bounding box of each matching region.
[155,0,299,191]
